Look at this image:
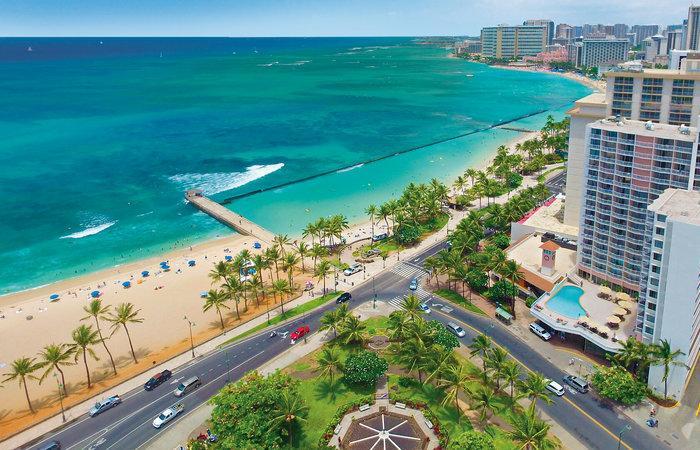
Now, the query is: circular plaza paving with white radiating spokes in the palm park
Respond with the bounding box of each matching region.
[341,412,428,450]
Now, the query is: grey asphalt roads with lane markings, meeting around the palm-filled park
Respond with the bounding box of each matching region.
[29,243,666,450]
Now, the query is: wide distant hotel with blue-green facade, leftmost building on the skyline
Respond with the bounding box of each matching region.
[481,25,548,58]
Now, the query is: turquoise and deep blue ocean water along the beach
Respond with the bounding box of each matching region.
[0,38,589,294]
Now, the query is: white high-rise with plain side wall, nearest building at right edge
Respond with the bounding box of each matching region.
[636,188,700,398]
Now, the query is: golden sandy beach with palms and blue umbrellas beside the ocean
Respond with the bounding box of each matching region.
[0,120,537,438]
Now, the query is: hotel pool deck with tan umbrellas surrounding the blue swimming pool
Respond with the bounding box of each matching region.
[530,280,637,353]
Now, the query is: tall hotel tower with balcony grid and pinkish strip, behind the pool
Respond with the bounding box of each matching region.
[567,117,700,292]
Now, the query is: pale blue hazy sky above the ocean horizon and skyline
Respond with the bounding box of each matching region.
[0,0,689,36]
